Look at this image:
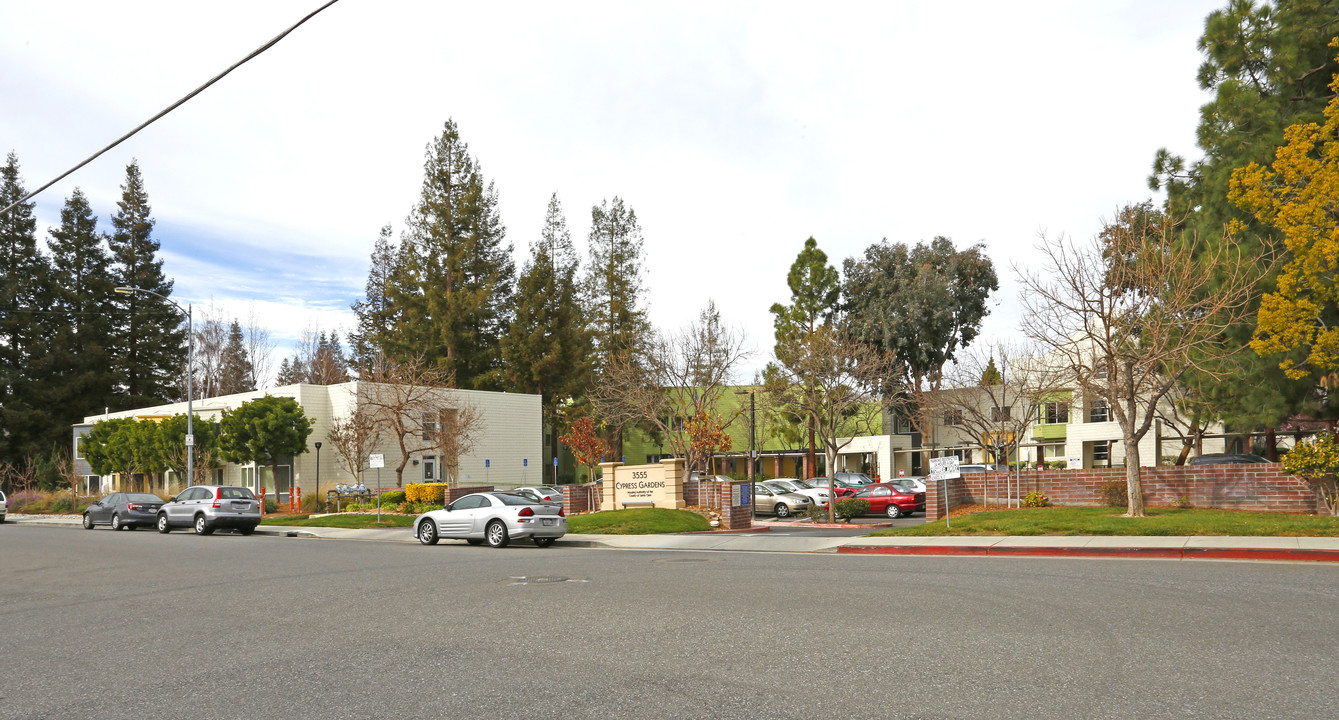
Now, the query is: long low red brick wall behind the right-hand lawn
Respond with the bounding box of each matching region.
[925,463,1324,519]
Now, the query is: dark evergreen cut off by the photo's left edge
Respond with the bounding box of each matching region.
[0,153,54,460]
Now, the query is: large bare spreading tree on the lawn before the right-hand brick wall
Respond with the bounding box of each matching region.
[1015,205,1257,517]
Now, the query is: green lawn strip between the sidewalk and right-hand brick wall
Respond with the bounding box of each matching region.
[870,507,1339,537]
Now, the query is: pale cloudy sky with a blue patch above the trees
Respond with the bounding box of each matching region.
[0,0,1227,381]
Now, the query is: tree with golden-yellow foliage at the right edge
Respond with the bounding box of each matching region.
[1228,37,1339,380]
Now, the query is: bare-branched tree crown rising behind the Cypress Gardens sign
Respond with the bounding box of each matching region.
[592,302,750,470]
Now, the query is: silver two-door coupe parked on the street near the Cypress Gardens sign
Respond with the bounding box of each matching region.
[414,492,568,547]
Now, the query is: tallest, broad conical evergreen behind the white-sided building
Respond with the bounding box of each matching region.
[384,120,516,389]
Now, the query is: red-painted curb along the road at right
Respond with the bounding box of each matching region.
[837,545,1339,562]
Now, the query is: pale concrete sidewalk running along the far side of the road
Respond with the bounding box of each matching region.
[8,515,1339,562]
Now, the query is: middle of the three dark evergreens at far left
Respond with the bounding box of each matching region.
[47,189,118,443]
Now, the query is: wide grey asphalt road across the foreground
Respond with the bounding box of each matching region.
[0,525,1339,720]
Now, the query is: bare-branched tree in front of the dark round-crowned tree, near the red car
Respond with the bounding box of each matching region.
[767,325,893,521]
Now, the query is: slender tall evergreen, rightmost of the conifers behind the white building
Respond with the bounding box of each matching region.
[585,197,651,458]
